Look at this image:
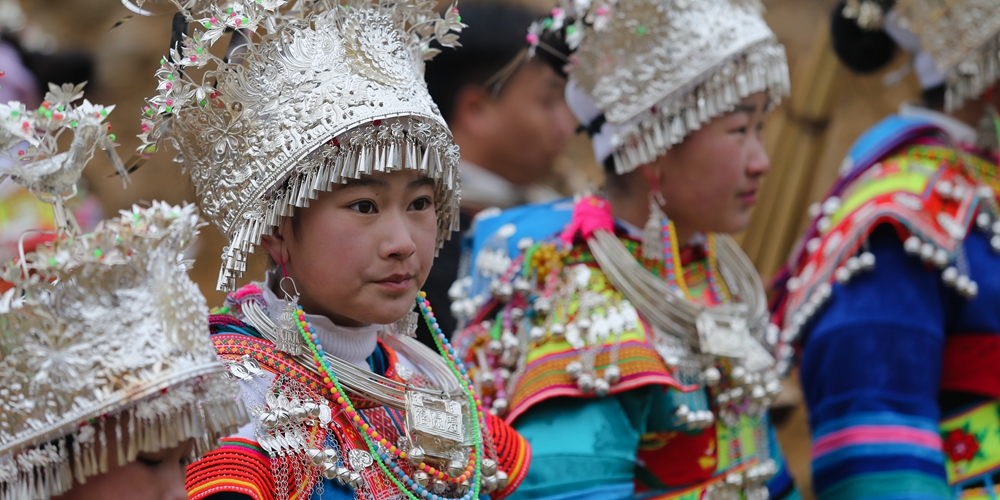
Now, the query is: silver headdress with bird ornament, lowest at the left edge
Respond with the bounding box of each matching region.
[0,88,247,499]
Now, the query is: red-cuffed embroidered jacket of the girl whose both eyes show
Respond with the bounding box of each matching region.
[187,284,531,500]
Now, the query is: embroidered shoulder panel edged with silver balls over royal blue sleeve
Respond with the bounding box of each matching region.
[775,141,996,342]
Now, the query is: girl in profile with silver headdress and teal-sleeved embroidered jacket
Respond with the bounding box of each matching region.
[454,0,797,499]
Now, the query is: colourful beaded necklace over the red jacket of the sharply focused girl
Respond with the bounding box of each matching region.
[295,292,486,500]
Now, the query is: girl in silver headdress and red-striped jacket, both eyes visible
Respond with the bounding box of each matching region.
[136,0,529,500]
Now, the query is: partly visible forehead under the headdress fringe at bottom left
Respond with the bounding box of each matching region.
[54,435,194,500]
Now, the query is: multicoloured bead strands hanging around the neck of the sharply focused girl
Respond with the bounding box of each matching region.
[296,299,482,500]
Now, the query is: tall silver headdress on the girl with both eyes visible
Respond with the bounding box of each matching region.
[140,0,462,290]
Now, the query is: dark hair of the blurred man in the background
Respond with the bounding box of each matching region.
[424,2,535,122]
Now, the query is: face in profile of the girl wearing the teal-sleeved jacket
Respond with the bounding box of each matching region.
[643,92,771,243]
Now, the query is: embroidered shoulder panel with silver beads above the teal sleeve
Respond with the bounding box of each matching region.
[456,236,682,422]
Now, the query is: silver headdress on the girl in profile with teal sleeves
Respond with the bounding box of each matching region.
[528,0,790,173]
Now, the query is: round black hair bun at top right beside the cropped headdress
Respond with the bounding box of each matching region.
[830,0,896,73]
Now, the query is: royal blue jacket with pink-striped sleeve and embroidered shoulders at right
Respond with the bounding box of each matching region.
[775,116,1000,499]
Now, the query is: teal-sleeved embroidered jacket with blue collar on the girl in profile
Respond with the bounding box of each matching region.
[453,200,798,499]
